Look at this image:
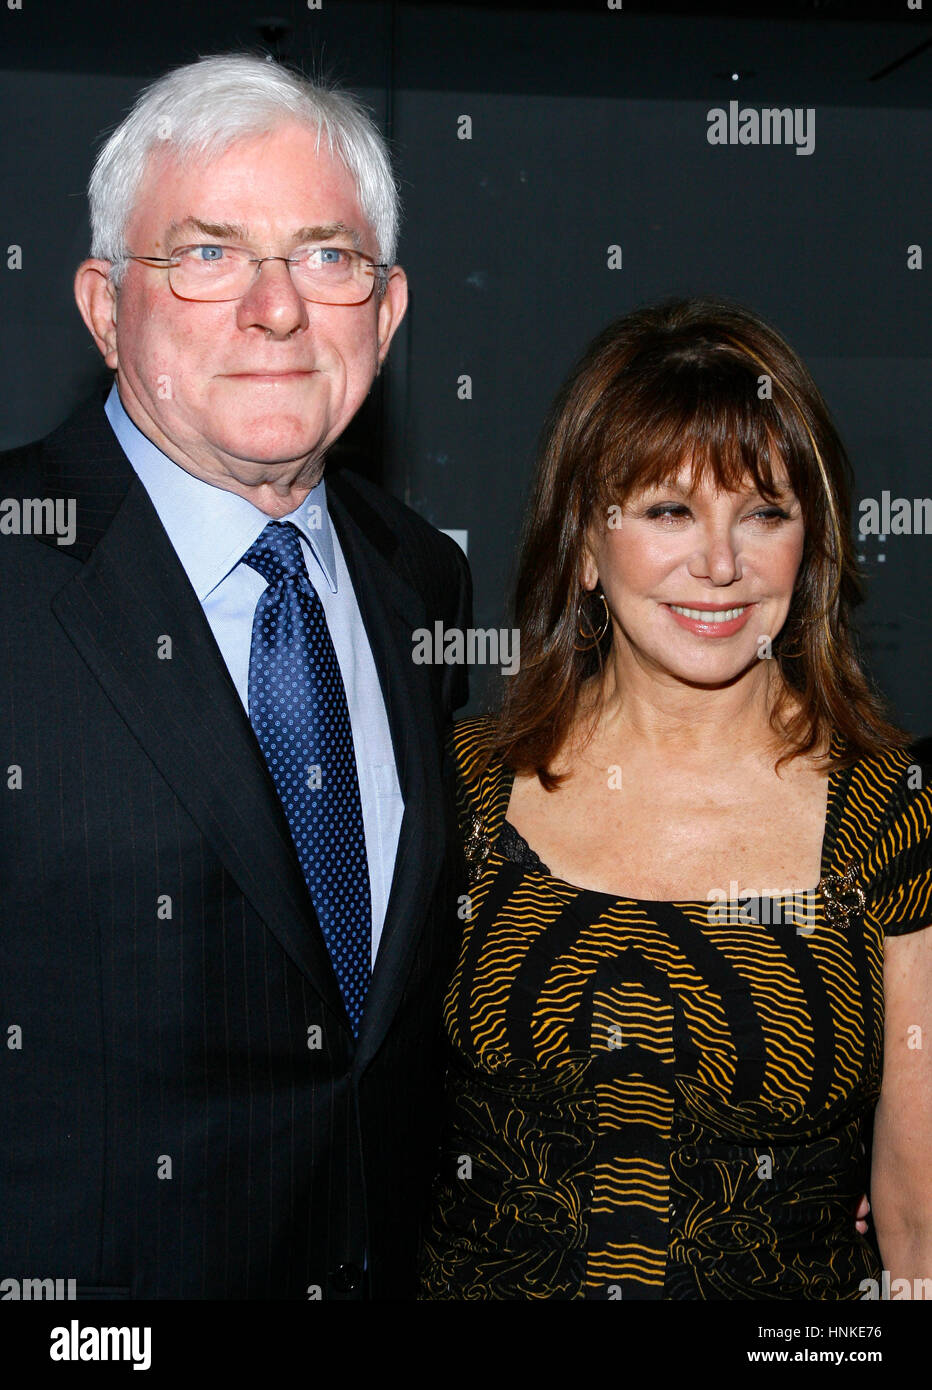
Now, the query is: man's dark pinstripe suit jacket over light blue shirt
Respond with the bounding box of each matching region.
[0,400,471,1298]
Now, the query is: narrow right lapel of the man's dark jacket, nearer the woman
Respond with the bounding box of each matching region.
[326,473,444,1068]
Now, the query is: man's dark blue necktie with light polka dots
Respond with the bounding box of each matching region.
[243,521,372,1034]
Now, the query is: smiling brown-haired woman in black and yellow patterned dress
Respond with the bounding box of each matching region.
[422,300,932,1300]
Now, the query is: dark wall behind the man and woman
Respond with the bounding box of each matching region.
[0,0,932,734]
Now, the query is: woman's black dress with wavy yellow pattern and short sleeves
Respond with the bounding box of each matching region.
[421,719,932,1300]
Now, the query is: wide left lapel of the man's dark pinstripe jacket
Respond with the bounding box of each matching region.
[44,404,346,1022]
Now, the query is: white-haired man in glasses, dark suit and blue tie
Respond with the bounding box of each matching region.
[0,56,469,1298]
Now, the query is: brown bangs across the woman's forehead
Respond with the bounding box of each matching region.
[599,357,808,502]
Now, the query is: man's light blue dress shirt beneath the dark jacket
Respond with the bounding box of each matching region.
[104,384,404,960]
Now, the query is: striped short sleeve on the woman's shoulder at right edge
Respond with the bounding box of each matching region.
[860,765,932,937]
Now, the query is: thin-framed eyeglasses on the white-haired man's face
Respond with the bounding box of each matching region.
[125,245,389,304]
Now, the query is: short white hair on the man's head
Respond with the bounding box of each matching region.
[88,53,400,285]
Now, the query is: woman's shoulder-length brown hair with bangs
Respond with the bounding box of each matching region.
[488,299,907,790]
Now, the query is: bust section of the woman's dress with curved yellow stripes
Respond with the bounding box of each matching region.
[446,878,883,1134]
